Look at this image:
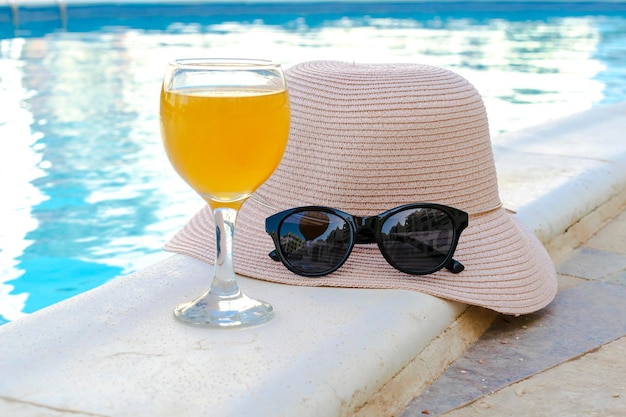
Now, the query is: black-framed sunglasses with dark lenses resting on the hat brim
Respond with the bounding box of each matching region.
[265,203,468,277]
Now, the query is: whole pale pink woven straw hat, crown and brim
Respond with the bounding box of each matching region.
[166,61,557,314]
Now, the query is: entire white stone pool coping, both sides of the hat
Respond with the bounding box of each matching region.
[0,103,626,417]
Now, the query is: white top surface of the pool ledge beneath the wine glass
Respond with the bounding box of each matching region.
[0,256,464,416]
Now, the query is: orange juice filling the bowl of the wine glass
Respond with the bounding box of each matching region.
[161,89,289,208]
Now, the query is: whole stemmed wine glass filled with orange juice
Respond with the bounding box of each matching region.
[160,58,290,327]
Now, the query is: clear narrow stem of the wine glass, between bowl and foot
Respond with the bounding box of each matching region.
[210,207,240,297]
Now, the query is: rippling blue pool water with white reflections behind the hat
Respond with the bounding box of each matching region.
[0,0,626,324]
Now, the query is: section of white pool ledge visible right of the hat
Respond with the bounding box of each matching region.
[493,103,626,259]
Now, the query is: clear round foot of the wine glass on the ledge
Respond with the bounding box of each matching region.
[174,291,274,328]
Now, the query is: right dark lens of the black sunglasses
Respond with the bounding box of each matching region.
[381,208,454,274]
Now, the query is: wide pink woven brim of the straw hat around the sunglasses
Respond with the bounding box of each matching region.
[165,198,557,315]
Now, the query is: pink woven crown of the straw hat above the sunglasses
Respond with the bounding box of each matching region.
[258,61,500,215]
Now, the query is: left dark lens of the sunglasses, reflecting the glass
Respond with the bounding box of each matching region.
[279,211,351,276]
